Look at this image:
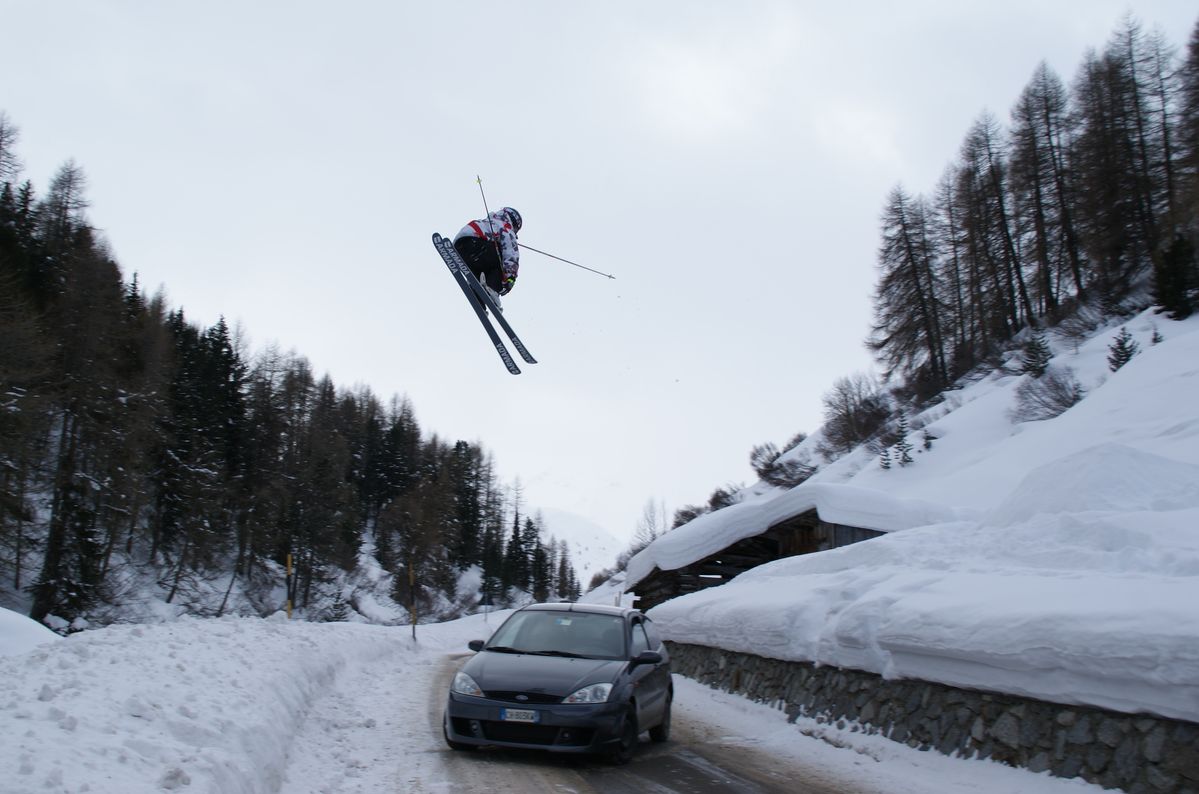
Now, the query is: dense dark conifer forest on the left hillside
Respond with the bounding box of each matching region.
[0,121,579,625]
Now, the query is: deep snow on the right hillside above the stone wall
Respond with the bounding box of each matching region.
[629,313,1199,721]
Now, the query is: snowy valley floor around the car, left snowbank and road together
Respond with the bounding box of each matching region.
[0,613,1099,794]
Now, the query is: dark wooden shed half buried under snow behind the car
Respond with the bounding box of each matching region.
[631,509,885,609]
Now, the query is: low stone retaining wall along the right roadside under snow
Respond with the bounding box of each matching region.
[667,643,1199,794]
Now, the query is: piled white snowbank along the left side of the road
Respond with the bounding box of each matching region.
[0,615,499,794]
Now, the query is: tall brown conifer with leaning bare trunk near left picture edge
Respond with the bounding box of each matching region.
[31,163,129,619]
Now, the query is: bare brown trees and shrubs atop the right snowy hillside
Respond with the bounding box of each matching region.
[671,16,1199,534]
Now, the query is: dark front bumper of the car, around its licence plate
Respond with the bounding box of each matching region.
[445,692,626,753]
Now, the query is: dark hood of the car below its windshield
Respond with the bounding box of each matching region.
[462,650,628,697]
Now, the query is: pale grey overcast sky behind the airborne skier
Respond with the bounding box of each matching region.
[0,0,1199,537]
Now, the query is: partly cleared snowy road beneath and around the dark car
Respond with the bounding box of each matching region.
[282,654,866,794]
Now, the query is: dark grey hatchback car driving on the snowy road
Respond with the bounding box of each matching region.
[445,603,674,763]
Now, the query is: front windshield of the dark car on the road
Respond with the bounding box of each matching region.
[487,609,627,658]
